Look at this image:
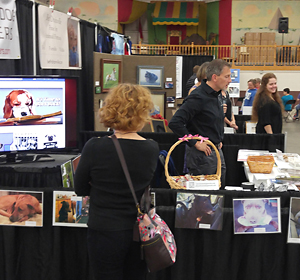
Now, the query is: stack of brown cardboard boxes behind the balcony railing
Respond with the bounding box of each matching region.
[245,32,275,63]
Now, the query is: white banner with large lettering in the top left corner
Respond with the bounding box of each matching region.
[0,0,21,59]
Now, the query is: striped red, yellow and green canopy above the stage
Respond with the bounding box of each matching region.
[153,2,199,25]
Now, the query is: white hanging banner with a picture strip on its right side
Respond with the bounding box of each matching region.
[38,5,81,69]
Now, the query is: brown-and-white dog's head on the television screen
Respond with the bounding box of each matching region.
[3,89,34,119]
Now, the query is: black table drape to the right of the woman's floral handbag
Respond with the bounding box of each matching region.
[150,189,300,280]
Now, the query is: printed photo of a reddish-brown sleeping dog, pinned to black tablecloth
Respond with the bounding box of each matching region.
[0,190,43,227]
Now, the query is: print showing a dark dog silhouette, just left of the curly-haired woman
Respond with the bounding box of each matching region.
[52,191,90,227]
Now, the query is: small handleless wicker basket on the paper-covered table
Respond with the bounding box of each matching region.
[247,155,275,174]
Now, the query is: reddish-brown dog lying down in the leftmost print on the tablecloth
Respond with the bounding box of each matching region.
[0,194,42,223]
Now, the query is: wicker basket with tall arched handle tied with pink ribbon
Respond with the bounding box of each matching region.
[165,136,221,189]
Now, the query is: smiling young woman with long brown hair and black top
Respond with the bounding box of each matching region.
[252,73,284,134]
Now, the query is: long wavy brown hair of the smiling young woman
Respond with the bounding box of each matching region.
[251,73,284,121]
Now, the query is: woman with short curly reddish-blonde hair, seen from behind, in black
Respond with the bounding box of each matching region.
[74,84,159,280]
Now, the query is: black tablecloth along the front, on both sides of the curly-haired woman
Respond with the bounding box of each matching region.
[0,186,300,280]
